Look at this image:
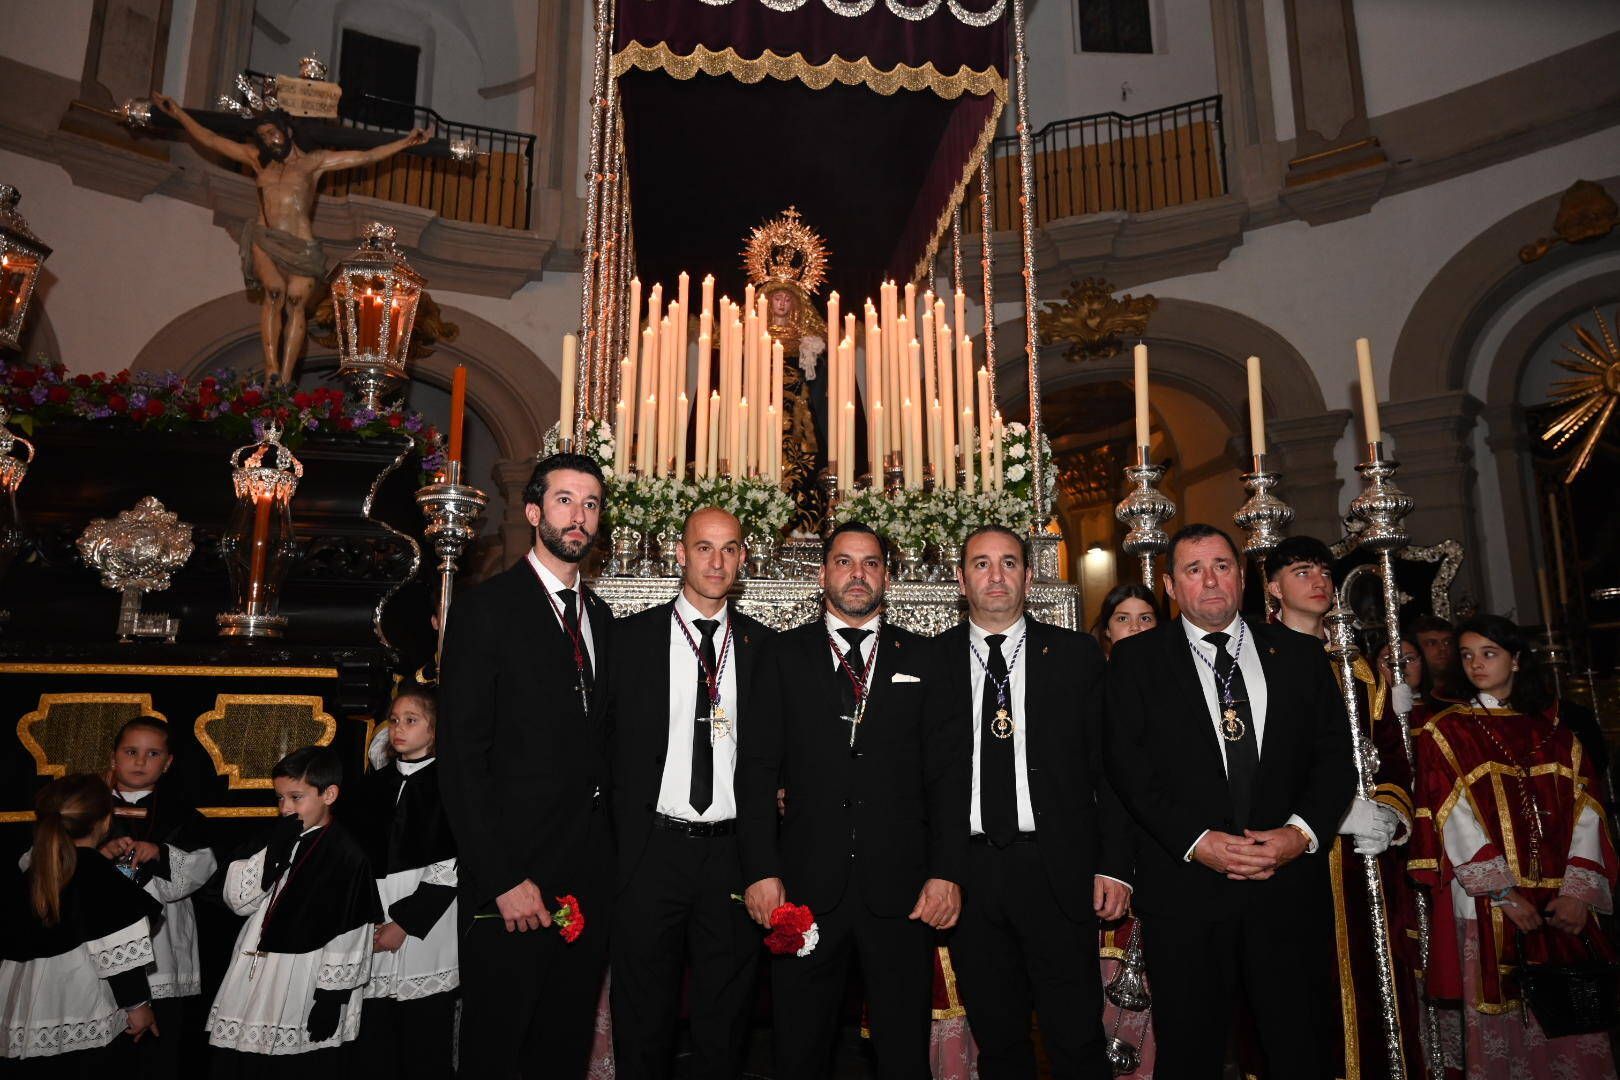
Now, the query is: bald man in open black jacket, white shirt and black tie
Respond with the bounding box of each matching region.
[608,507,771,1080]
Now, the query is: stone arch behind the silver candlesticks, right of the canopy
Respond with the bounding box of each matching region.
[996,298,1349,538]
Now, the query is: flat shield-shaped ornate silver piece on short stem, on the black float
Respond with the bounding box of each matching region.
[78,495,191,644]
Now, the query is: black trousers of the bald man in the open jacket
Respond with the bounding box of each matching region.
[611,827,763,1080]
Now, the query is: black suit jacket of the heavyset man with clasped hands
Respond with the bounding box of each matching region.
[1106,619,1356,918]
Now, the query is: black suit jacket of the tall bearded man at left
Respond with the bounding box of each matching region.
[437,559,612,908]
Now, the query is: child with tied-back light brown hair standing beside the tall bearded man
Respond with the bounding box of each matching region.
[360,685,462,1077]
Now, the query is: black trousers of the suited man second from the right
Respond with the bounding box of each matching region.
[949,840,1113,1080]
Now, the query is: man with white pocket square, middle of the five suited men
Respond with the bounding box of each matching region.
[737,521,970,1080]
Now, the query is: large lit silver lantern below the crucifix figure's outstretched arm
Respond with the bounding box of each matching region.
[327,222,423,411]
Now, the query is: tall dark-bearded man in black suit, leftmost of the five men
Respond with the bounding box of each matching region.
[439,453,614,1077]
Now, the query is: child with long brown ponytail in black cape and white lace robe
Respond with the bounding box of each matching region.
[0,772,162,1077]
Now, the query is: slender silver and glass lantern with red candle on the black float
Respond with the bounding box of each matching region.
[219,424,303,638]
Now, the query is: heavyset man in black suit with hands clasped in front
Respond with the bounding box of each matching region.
[1108,525,1356,1078]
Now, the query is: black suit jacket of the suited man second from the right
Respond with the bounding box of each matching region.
[938,615,1132,920]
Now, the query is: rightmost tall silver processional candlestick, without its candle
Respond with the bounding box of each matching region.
[1349,442,1443,1078]
